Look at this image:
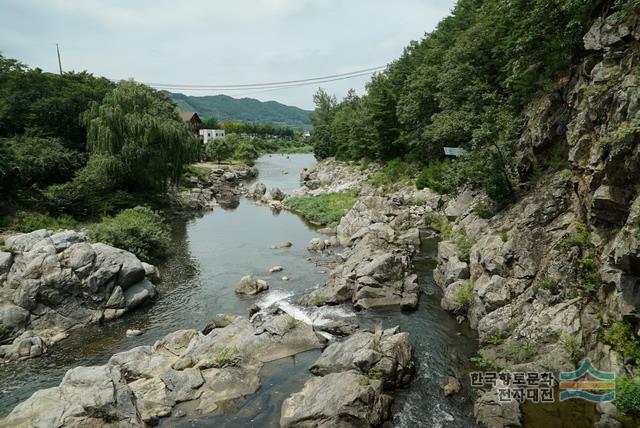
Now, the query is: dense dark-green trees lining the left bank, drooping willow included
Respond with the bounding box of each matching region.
[0,56,198,218]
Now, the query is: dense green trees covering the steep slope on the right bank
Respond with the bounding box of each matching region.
[312,0,616,199]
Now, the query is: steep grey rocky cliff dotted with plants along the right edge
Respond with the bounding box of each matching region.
[434,15,640,427]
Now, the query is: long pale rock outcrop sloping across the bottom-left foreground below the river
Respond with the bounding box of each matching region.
[0,313,322,427]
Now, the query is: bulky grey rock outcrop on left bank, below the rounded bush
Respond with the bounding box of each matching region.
[0,230,160,361]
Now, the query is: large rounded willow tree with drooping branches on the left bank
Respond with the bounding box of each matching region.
[81,81,198,191]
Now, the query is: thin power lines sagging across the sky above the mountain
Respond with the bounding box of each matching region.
[146,66,386,91]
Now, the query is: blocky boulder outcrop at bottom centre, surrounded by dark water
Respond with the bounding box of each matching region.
[280,328,413,427]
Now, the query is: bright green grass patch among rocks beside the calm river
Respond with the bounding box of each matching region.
[285,190,358,227]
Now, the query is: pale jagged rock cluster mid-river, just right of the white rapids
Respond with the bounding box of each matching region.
[302,174,442,309]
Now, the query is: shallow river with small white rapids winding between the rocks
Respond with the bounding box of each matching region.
[0,154,475,427]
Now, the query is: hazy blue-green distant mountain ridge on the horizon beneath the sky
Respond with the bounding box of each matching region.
[166,92,311,129]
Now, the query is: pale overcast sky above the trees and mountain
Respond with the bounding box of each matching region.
[0,0,454,109]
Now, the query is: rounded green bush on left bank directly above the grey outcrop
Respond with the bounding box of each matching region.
[88,207,171,261]
